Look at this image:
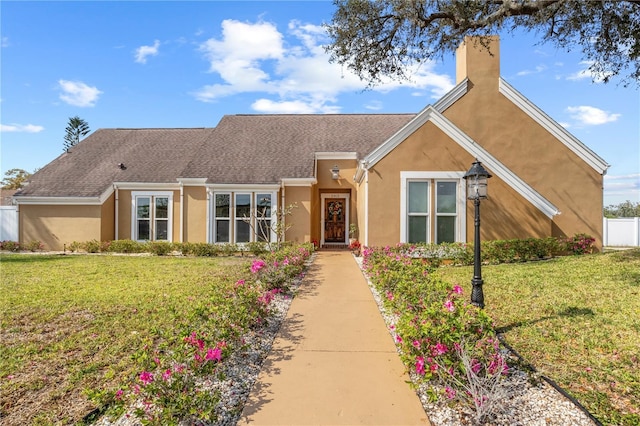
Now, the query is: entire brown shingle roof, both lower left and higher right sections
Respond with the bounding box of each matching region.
[18,114,415,197]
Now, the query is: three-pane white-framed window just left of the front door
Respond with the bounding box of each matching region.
[211,191,276,243]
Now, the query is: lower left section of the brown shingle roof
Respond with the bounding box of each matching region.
[18,128,213,197]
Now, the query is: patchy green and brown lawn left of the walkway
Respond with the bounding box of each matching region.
[0,254,247,425]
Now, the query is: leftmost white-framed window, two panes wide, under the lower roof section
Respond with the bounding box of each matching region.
[131,192,173,241]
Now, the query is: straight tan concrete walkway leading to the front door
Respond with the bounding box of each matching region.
[238,251,430,425]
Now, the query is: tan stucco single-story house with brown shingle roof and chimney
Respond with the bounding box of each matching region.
[15,37,608,250]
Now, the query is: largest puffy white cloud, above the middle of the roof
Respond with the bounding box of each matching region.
[193,20,454,113]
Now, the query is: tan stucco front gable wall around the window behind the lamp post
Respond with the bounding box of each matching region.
[368,122,551,246]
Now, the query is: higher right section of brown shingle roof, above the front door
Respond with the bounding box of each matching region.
[182,114,415,184]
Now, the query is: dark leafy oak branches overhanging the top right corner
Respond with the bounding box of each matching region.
[325,0,640,86]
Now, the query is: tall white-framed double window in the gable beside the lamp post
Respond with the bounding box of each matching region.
[400,172,466,244]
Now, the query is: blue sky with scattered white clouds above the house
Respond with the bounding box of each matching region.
[0,0,640,205]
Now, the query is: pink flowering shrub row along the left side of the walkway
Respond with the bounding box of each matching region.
[99,245,313,425]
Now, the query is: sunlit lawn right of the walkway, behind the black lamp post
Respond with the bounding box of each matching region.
[437,249,640,425]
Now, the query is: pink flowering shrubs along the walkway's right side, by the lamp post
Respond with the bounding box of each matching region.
[363,245,506,420]
